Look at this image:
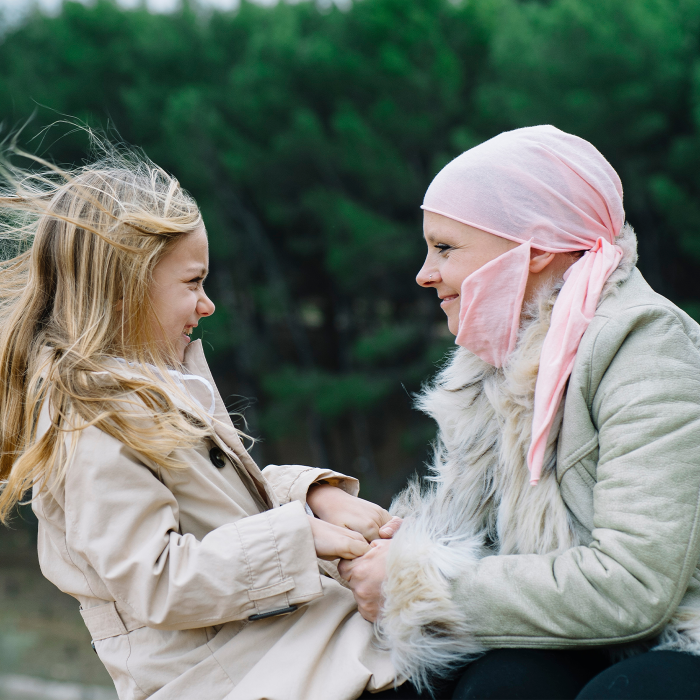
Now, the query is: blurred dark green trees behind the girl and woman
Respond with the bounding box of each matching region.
[0,0,700,679]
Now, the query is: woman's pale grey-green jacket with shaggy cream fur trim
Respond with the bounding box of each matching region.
[382,228,700,678]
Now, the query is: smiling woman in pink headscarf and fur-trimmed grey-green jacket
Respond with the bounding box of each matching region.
[341,126,700,700]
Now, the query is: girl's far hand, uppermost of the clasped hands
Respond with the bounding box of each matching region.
[306,484,398,542]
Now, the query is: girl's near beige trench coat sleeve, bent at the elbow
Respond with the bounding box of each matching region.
[65,428,323,630]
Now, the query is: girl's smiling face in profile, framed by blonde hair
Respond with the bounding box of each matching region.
[151,226,214,362]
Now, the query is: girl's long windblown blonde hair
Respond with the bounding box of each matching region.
[0,134,216,522]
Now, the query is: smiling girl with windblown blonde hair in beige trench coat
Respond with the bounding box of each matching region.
[0,141,406,700]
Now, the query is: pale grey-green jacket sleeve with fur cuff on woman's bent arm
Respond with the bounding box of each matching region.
[385,307,700,672]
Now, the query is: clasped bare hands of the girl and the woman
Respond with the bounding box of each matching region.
[306,484,401,622]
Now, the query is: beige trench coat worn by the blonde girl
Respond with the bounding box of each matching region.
[34,342,394,700]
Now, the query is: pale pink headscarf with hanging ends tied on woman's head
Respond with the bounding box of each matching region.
[422,126,625,484]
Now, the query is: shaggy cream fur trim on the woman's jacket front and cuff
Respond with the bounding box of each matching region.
[380,225,637,687]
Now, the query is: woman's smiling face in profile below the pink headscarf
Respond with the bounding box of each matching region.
[416,211,520,335]
